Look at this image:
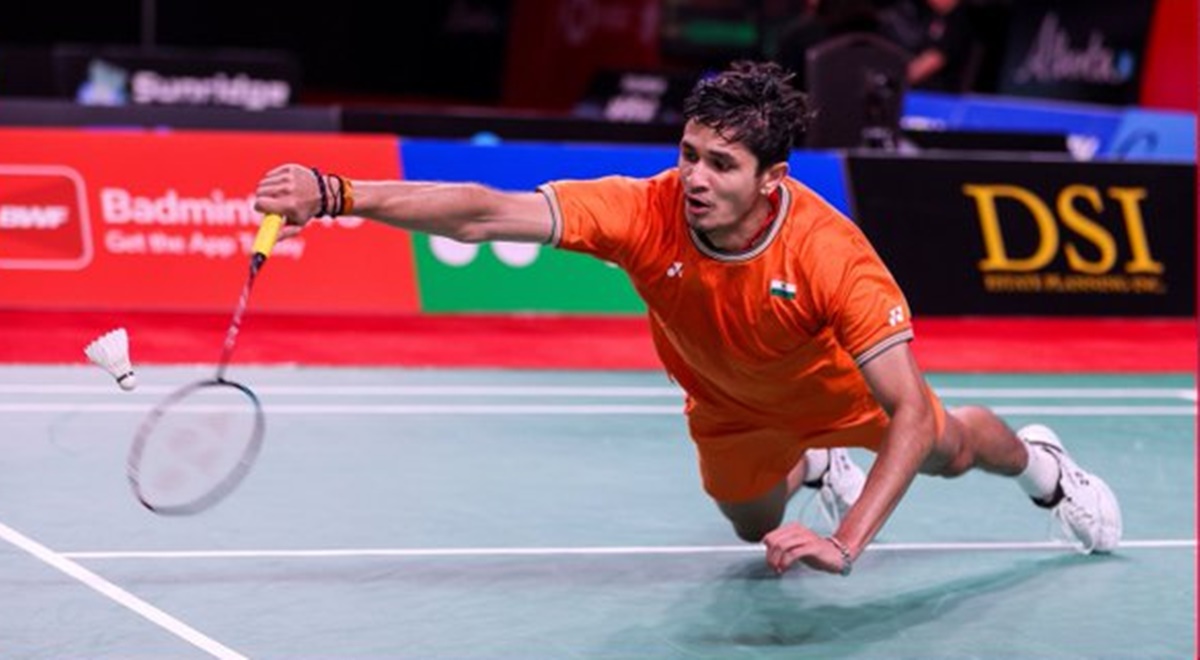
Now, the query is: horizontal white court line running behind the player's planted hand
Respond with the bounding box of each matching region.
[61,539,1196,559]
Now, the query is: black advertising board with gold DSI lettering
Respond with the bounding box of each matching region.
[850,155,1196,316]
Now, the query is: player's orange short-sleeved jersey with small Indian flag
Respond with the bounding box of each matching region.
[540,169,912,440]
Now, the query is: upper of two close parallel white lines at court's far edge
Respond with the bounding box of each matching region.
[0,383,1196,401]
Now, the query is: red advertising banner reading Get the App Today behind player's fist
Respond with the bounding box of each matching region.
[0,130,416,314]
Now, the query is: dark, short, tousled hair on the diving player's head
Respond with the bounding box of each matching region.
[683,61,811,172]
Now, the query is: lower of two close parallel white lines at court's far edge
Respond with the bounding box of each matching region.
[0,403,1196,416]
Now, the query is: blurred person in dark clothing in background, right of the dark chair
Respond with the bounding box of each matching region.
[878,0,979,91]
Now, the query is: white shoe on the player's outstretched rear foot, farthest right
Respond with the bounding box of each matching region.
[1016,424,1121,554]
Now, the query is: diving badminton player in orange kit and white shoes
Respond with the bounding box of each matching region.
[254,62,1121,575]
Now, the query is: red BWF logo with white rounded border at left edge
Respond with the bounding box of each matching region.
[0,166,92,270]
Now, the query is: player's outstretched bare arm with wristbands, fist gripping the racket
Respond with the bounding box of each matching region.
[254,163,554,242]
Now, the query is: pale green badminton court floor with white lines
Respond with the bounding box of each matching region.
[0,366,1196,660]
